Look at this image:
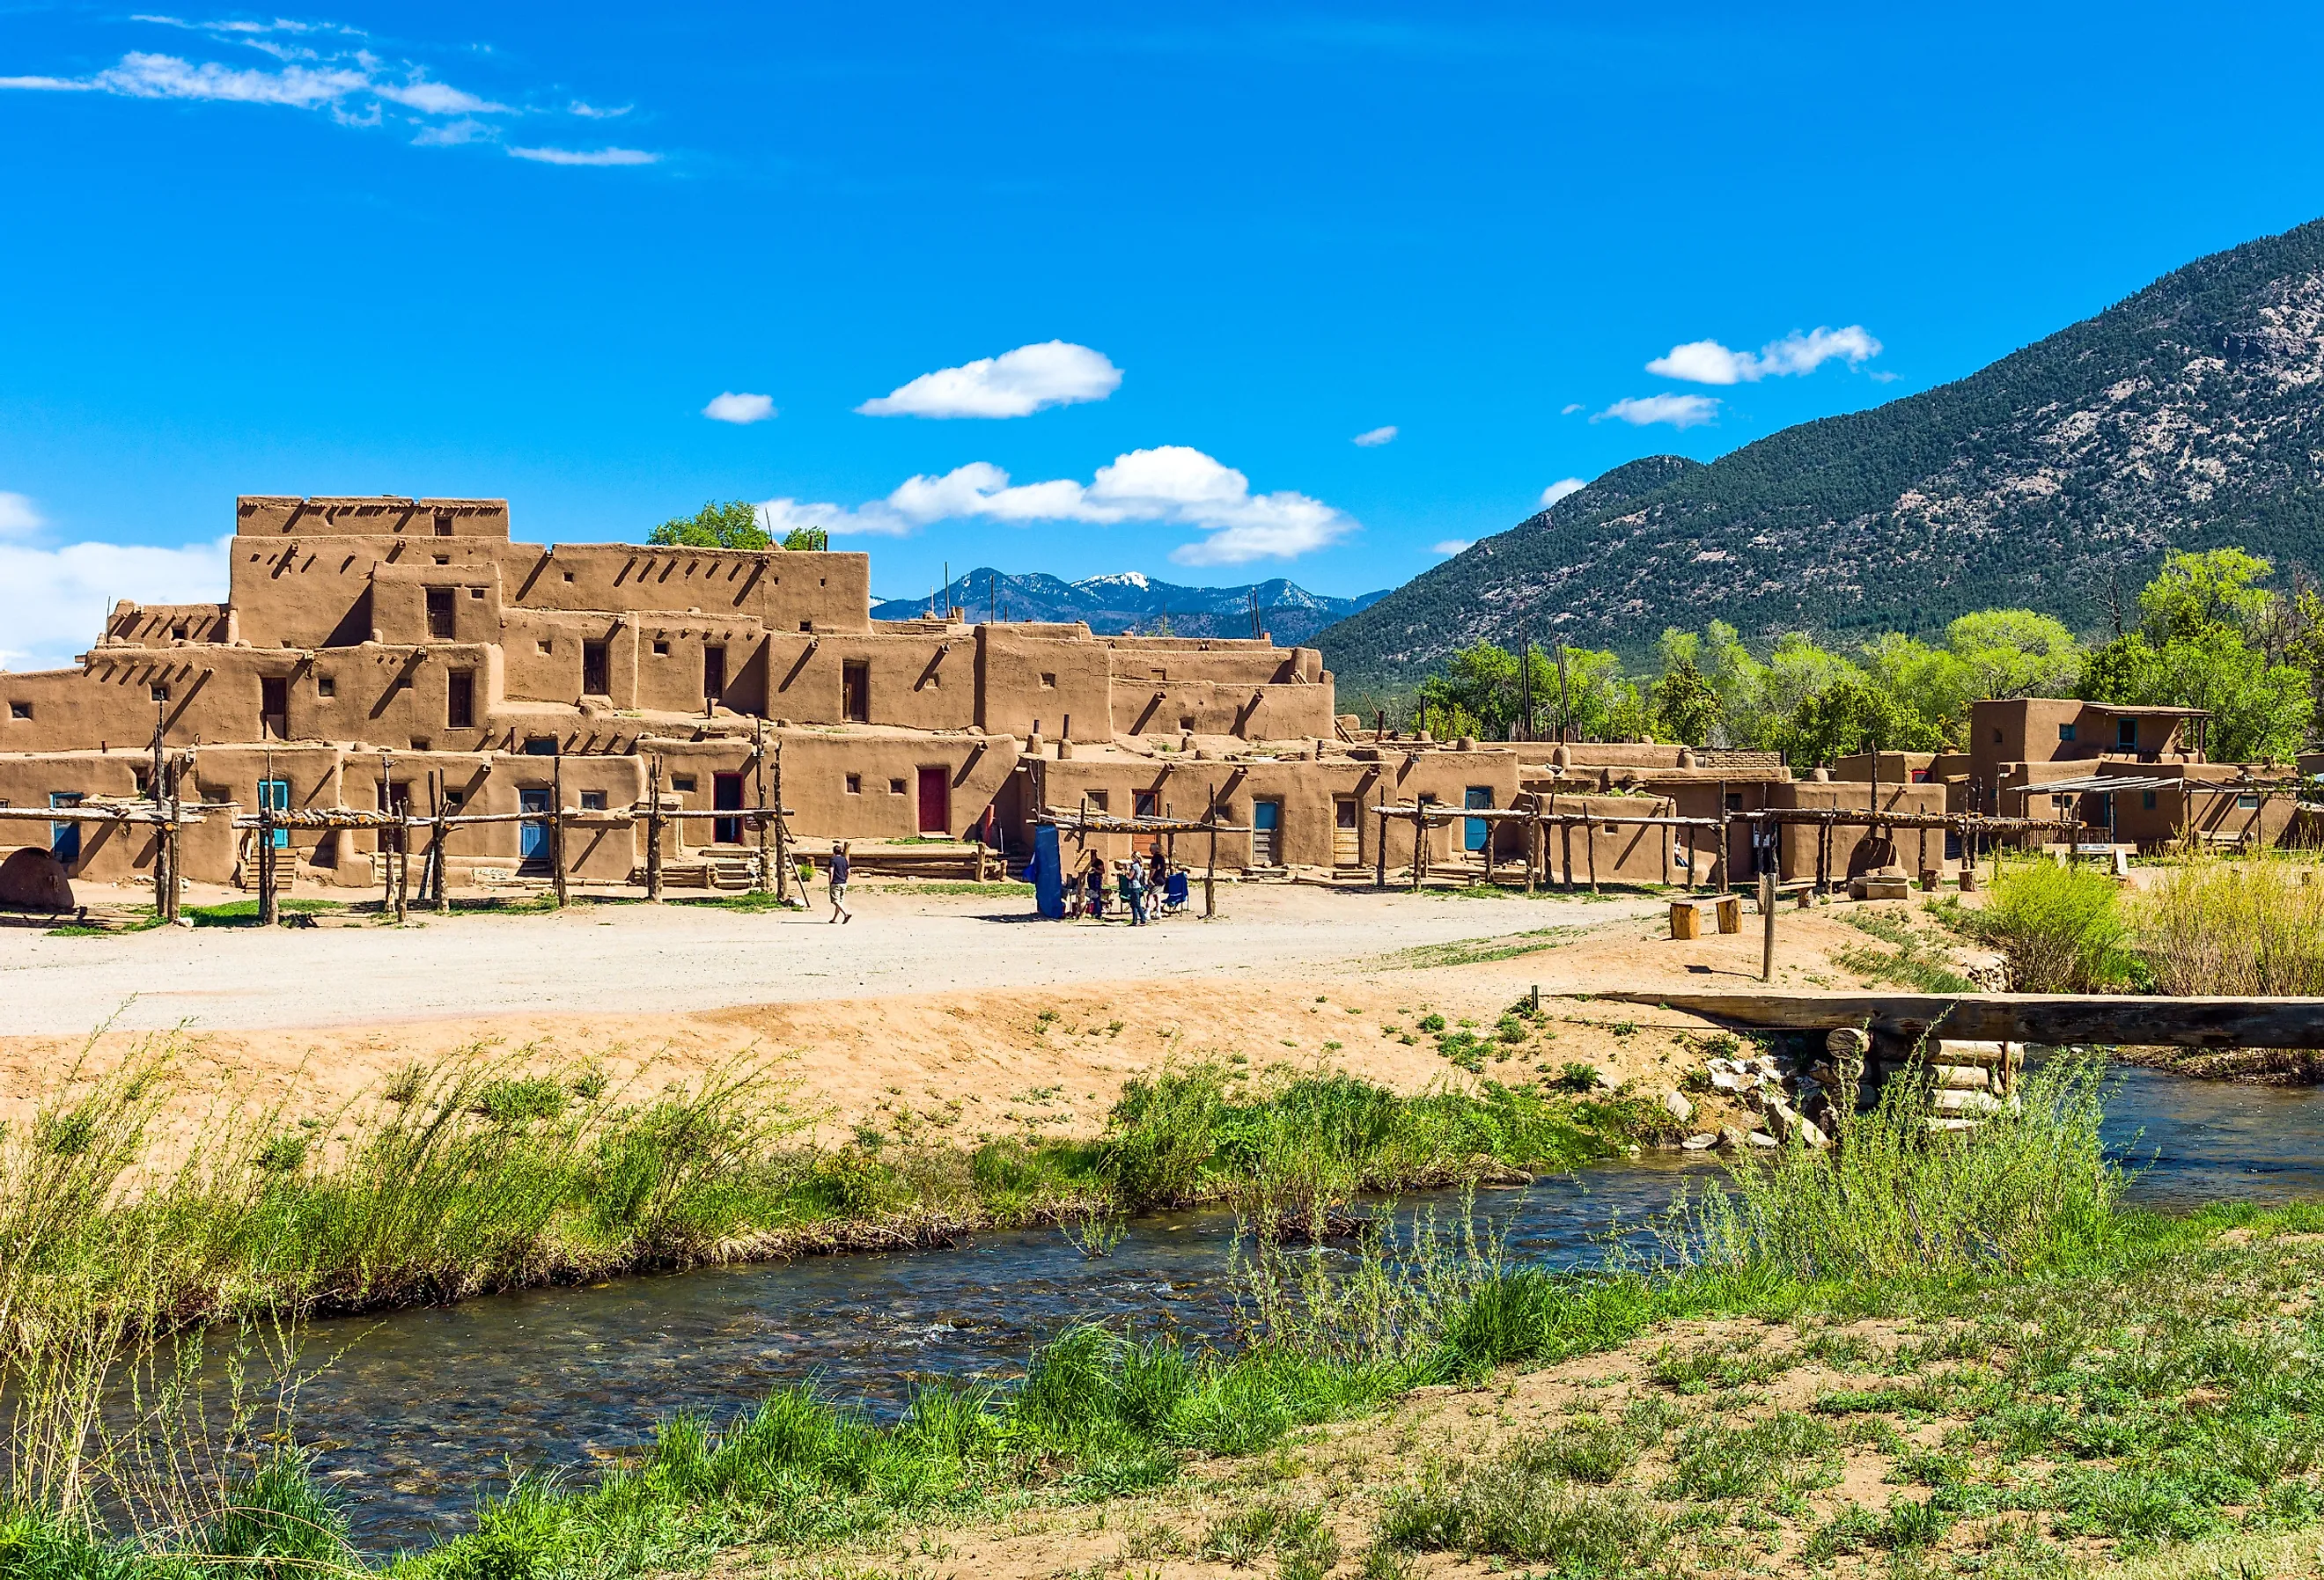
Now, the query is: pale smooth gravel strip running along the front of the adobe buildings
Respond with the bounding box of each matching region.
[0,886,1657,1036]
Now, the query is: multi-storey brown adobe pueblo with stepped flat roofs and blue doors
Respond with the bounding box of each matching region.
[0,495,2289,908]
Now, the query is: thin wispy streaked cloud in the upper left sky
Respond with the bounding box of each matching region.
[0,14,662,165]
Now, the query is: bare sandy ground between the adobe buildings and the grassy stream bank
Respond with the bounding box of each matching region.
[0,886,1943,1141]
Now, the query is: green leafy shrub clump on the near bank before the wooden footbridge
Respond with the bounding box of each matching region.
[1671,1053,2124,1282]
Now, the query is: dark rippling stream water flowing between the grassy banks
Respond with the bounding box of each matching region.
[204,1069,2324,1552]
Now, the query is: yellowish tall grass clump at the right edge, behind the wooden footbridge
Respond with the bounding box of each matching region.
[2134,855,2324,996]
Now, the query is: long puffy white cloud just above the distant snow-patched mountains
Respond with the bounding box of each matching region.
[760,444,1355,564]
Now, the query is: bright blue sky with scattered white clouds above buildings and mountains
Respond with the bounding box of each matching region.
[0,3,2324,662]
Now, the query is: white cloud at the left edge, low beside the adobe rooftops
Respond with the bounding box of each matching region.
[0,529,235,669]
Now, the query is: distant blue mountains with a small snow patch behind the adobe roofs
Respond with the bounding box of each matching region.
[872,567,1387,646]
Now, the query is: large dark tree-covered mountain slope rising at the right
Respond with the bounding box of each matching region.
[1318,221,2324,693]
